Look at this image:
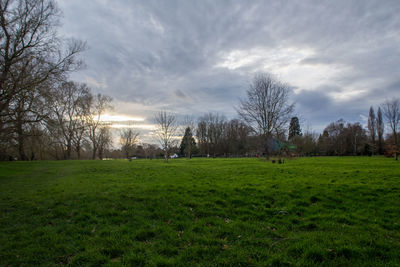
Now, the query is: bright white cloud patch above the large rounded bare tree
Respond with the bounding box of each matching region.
[214,47,350,92]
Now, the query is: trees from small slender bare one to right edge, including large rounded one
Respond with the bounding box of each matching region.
[148,74,400,163]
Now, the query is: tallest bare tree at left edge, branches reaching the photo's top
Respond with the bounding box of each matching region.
[0,0,85,159]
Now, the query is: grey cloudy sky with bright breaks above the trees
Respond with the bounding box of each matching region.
[58,0,400,141]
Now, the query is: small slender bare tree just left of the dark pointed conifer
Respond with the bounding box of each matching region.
[154,110,178,162]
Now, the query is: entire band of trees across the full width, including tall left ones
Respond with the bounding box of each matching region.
[0,0,400,160]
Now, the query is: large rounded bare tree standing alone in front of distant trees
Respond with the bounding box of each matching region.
[237,74,294,159]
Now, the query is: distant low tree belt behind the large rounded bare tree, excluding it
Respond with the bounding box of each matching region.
[149,96,400,162]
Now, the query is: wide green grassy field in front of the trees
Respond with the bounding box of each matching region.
[0,157,400,266]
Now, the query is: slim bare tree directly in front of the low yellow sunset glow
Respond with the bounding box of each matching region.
[85,94,112,159]
